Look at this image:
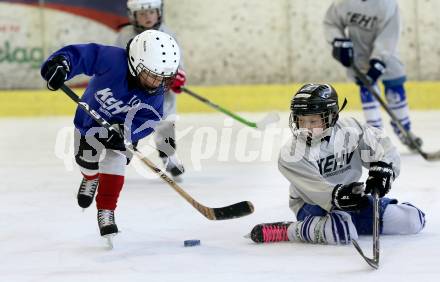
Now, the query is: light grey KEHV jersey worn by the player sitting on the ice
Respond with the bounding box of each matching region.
[278,118,400,214]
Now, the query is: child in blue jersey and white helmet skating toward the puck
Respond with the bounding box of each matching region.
[41,30,180,236]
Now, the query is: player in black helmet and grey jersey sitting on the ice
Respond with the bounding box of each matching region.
[250,84,425,244]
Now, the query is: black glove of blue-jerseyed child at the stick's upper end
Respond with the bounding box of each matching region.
[41,56,70,91]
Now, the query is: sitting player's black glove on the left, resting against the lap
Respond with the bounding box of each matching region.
[332,182,368,211]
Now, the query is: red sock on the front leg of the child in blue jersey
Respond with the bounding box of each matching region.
[96,173,124,210]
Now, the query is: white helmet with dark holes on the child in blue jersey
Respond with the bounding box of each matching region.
[127,29,180,87]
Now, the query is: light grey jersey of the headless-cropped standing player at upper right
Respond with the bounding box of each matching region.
[324,0,405,80]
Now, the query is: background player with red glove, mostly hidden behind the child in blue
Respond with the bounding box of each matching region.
[116,0,186,180]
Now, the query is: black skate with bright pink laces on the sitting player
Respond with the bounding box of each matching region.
[248,222,292,243]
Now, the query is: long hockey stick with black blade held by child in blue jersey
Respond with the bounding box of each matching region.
[61,85,254,220]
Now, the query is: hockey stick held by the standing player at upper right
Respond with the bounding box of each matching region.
[353,64,440,161]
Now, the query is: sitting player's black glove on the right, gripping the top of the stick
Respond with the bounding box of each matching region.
[365,162,394,197]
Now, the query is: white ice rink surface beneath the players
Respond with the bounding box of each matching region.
[0,111,440,282]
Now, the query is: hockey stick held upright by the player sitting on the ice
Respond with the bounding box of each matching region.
[352,189,380,269]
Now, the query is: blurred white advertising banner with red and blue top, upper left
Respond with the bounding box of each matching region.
[0,0,128,89]
